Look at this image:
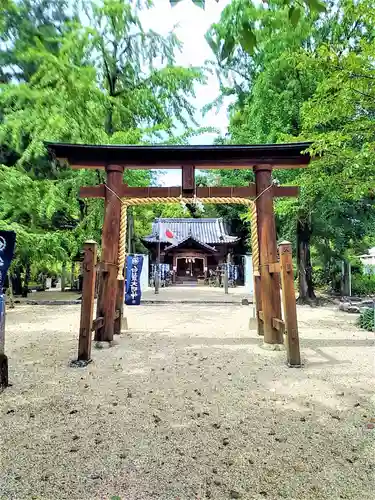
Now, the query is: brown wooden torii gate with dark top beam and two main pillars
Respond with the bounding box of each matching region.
[46,142,311,352]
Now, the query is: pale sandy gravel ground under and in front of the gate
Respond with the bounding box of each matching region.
[0,304,375,500]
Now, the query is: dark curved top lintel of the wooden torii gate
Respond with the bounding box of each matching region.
[45,142,312,169]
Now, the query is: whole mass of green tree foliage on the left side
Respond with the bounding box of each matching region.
[0,0,204,292]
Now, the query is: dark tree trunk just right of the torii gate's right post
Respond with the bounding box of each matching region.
[297,220,316,304]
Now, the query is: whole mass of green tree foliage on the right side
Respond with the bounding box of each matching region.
[207,0,375,300]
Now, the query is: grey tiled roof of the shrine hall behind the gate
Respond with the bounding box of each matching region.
[143,218,239,245]
